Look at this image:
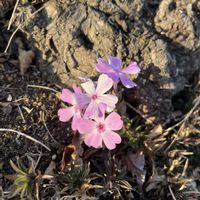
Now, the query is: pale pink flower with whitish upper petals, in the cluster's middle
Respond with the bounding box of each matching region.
[81,74,118,119]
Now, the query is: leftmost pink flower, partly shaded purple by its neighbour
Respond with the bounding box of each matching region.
[58,86,89,131]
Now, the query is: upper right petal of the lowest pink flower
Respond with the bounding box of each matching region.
[105,112,123,131]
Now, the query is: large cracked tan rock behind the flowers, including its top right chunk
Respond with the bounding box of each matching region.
[12,0,200,120]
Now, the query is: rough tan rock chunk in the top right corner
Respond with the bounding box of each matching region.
[154,0,200,50]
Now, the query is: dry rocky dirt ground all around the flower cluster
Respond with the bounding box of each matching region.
[0,0,200,200]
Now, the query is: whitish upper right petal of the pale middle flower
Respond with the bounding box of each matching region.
[96,74,113,94]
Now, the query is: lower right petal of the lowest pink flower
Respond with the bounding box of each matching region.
[102,131,122,150]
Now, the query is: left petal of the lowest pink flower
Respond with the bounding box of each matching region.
[78,118,96,134]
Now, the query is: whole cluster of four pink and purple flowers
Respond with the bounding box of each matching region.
[58,56,140,150]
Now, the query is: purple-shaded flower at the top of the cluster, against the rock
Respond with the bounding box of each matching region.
[96,56,140,88]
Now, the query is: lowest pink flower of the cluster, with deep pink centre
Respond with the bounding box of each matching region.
[78,107,123,150]
